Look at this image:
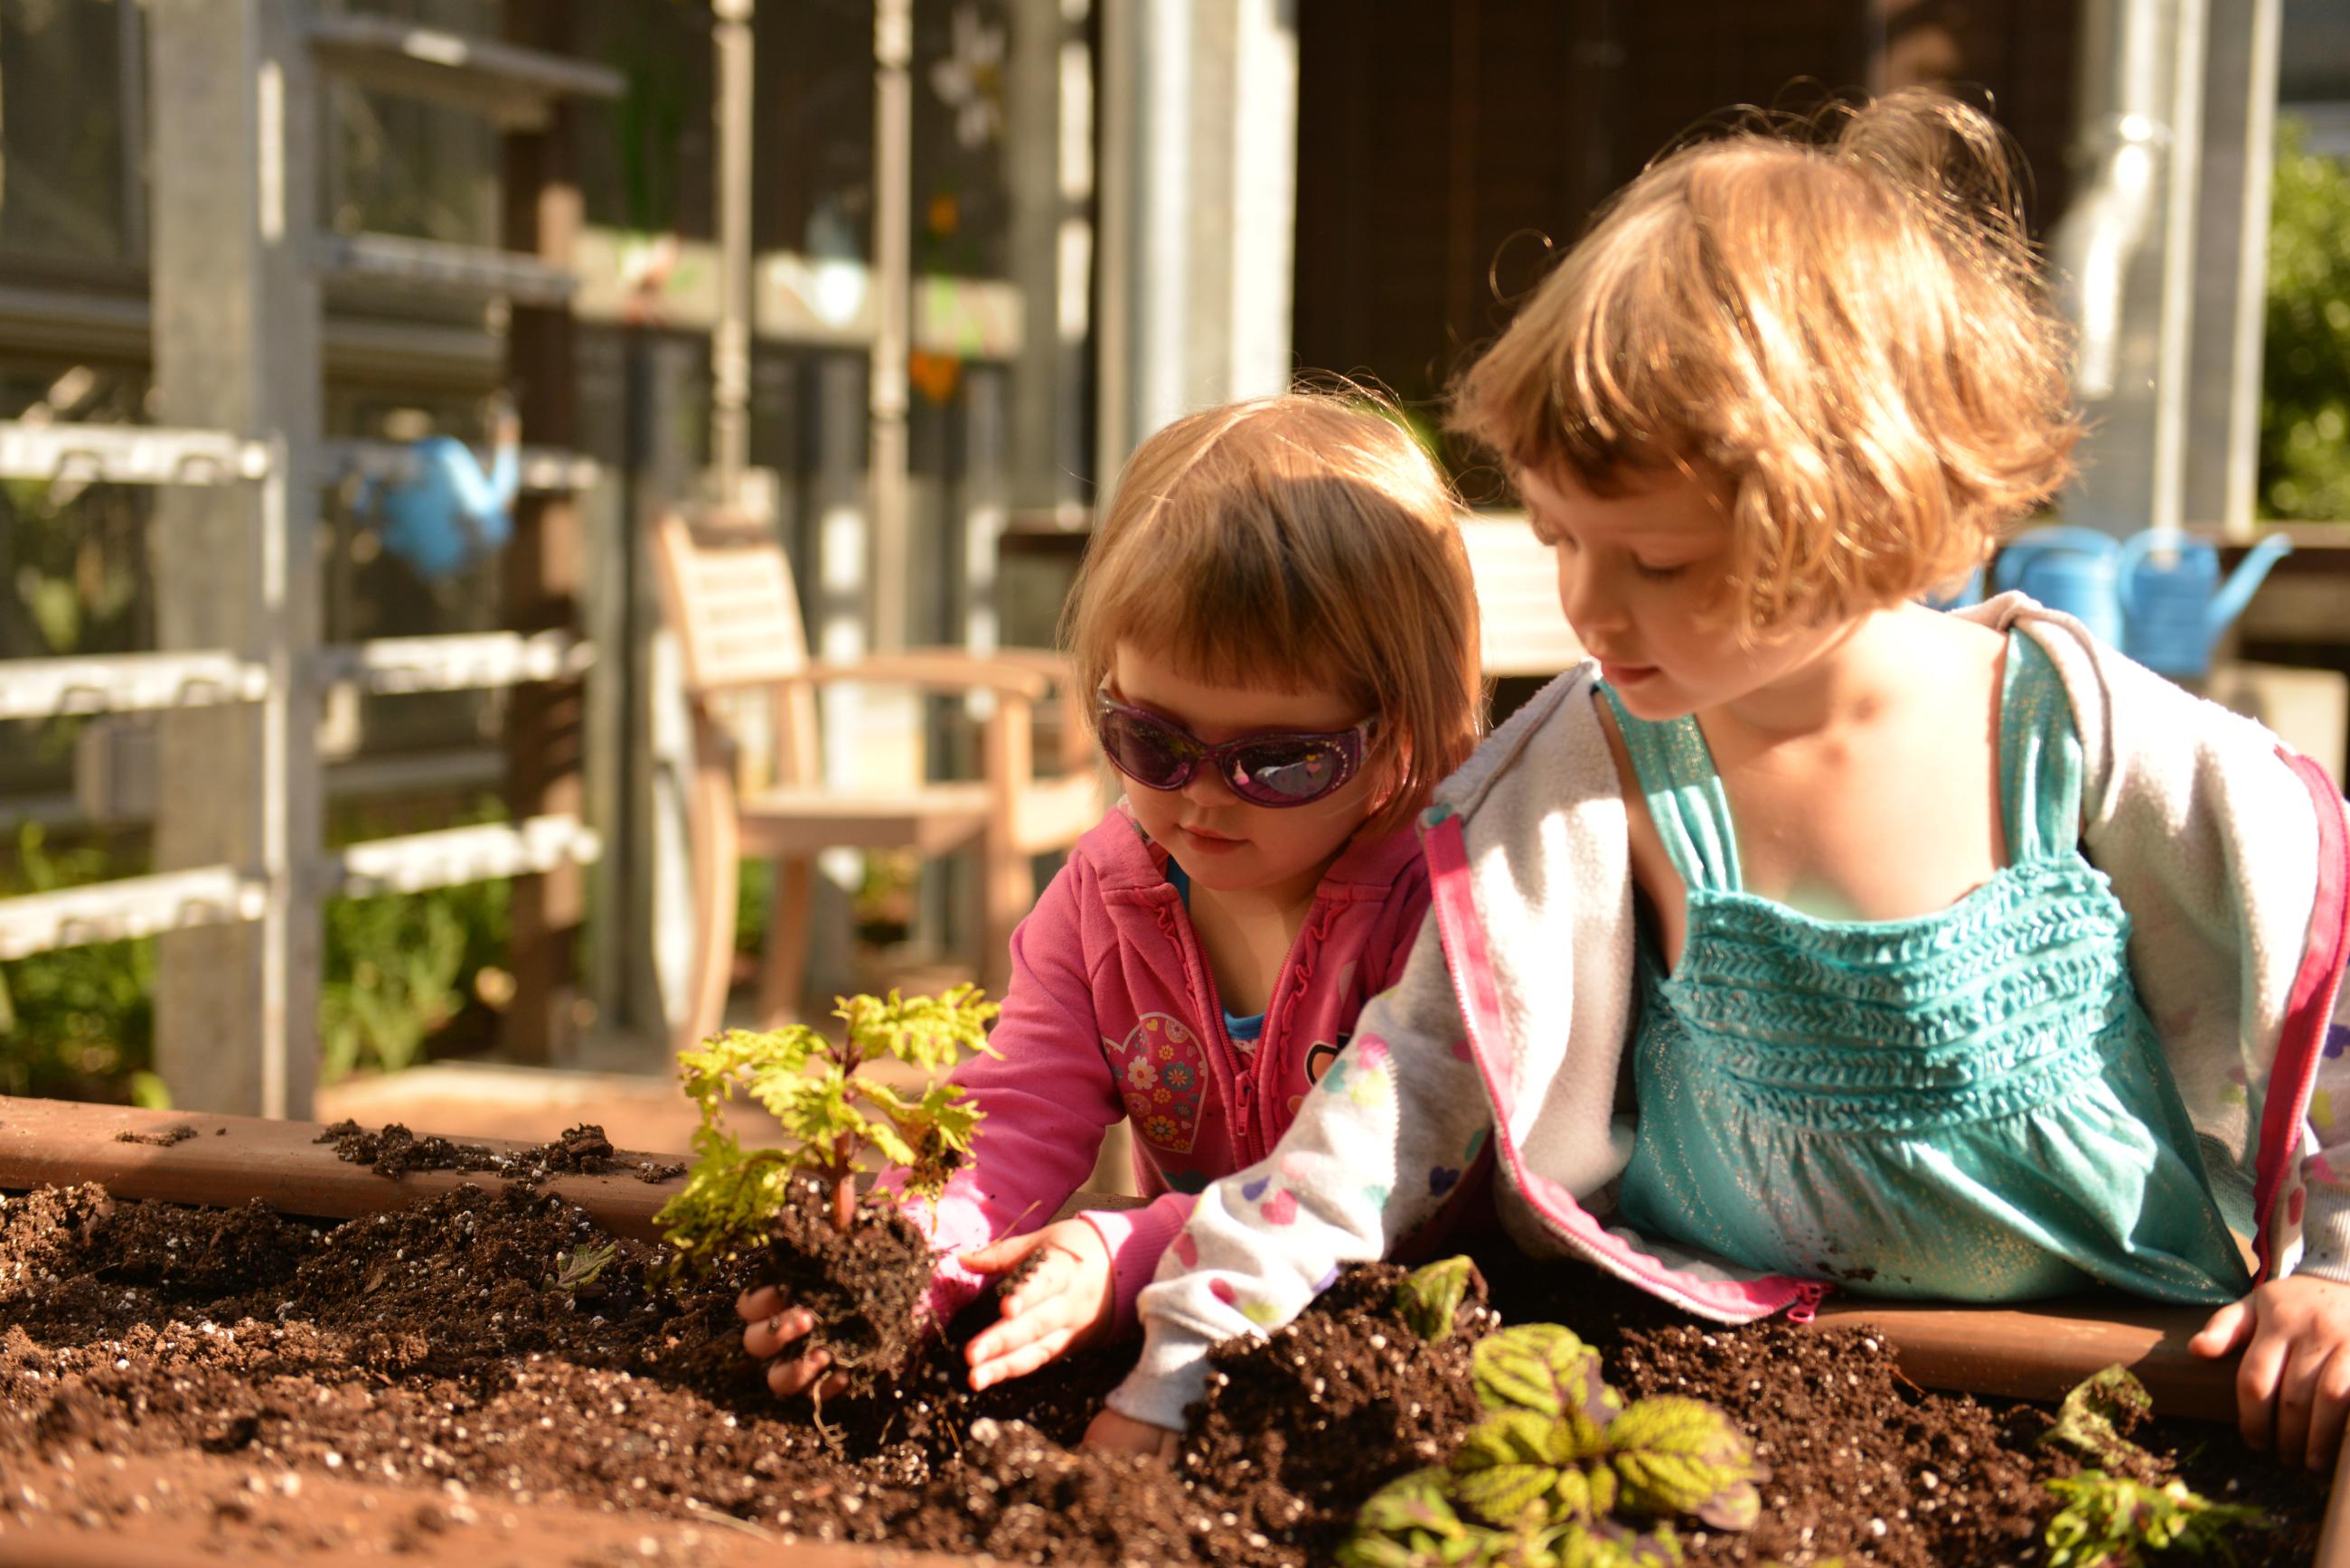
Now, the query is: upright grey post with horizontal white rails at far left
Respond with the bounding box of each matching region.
[0,0,623,1117]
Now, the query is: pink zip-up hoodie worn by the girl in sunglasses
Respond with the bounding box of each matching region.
[907,804,1429,1333]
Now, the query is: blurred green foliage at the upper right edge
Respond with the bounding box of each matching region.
[2259,117,2350,521]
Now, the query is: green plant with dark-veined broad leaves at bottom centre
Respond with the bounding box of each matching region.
[1340,1264,1760,1568]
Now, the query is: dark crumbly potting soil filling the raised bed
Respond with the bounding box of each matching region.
[0,1188,2324,1568]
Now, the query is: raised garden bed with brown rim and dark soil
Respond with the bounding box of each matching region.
[0,1100,2350,1568]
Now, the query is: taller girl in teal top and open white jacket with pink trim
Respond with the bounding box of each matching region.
[1093,91,2350,1465]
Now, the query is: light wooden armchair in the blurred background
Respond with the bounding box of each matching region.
[653,512,1102,1047]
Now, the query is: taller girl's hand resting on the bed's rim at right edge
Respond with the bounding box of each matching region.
[2188,1276,2350,1469]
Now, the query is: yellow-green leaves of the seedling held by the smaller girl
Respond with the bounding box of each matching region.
[655,985,996,1272]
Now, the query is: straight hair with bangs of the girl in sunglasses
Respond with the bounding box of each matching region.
[1062,392,1483,832]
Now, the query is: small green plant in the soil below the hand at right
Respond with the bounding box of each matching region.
[2040,1366,2268,1568]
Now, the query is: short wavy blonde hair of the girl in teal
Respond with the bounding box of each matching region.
[1454,89,2080,634]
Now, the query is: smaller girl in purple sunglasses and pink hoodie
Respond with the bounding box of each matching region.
[740,395,1480,1394]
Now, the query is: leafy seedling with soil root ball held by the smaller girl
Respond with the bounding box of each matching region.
[658,985,996,1392]
